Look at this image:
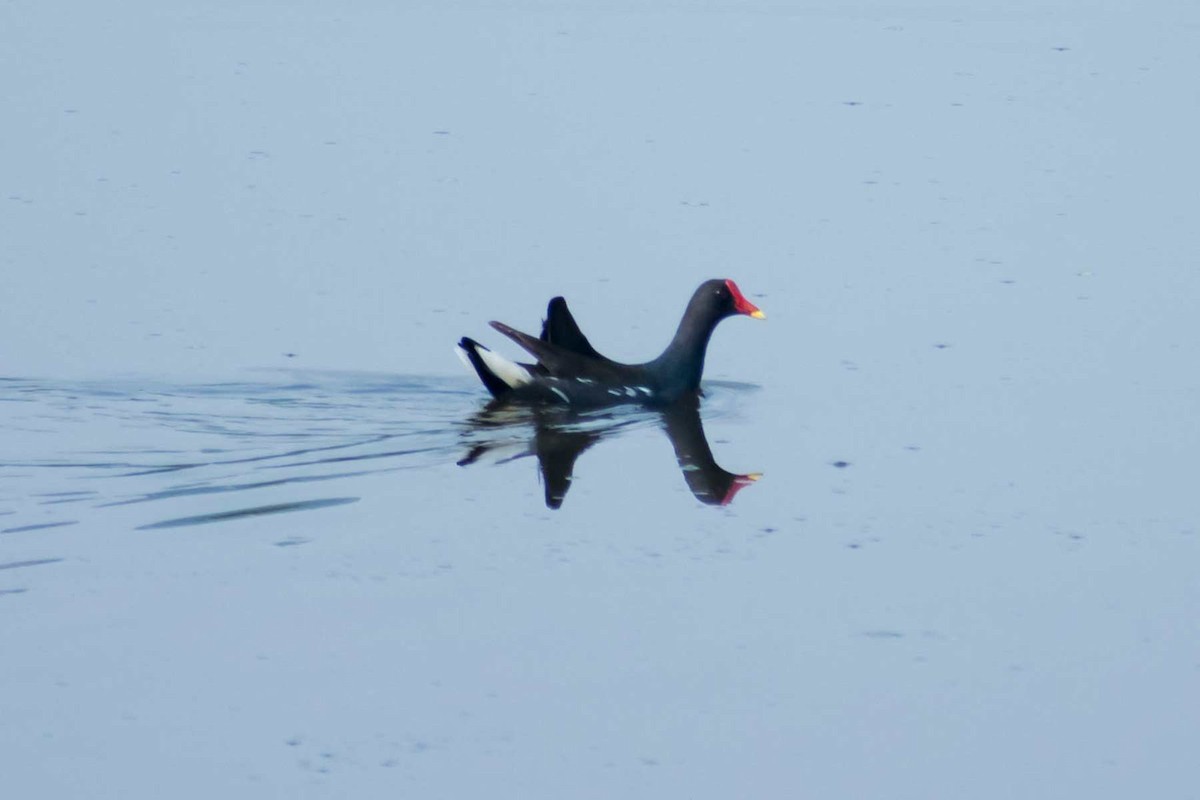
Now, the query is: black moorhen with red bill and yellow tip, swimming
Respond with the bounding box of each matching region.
[457,278,767,407]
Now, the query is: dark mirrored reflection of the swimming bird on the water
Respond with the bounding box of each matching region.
[458,398,761,509]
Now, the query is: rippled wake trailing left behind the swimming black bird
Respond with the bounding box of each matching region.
[0,372,755,535]
